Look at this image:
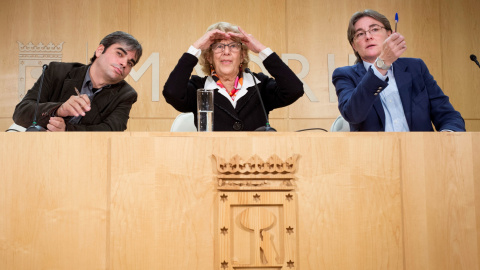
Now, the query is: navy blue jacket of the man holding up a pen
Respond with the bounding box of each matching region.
[332,58,465,131]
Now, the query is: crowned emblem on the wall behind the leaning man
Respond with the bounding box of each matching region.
[17,41,64,100]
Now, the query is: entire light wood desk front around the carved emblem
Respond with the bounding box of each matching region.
[0,132,480,270]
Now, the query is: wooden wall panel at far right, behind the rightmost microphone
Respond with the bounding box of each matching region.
[440,0,480,121]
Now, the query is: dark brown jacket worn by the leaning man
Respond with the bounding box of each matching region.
[13,62,137,131]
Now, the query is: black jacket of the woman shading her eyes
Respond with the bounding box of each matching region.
[163,53,303,131]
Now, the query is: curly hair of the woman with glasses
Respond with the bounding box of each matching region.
[199,22,250,75]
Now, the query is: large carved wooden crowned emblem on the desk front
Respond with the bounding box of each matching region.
[213,155,299,270]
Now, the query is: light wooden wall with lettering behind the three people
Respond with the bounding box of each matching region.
[0,0,480,131]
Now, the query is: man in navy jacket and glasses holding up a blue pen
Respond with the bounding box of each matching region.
[332,10,465,131]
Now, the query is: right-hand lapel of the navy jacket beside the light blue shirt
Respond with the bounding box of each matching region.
[393,59,412,129]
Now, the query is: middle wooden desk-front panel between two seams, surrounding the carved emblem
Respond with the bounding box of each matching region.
[110,134,403,269]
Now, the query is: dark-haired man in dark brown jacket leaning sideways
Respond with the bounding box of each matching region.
[13,31,142,131]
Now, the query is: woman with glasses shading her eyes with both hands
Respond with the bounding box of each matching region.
[163,22,303,131]
